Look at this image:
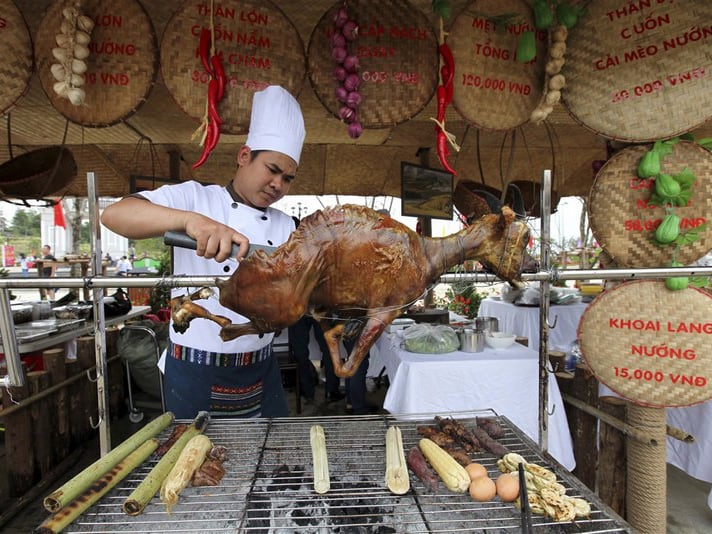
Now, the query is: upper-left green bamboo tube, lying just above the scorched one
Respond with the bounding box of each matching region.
[44,412,175,512]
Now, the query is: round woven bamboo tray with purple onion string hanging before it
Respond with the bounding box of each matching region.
[307,0,440,129]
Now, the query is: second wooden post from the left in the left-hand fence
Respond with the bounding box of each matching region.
[26,371,56,482]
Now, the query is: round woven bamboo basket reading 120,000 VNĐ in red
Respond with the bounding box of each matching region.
[447,0,548,130]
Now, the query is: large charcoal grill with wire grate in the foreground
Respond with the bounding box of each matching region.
[58,411,632,534]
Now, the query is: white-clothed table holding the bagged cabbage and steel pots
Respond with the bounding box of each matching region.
[371,332,576,470]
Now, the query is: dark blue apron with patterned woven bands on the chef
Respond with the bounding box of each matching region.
[164,342,289,419]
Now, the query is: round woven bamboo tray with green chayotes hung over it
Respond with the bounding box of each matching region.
[588,141,712,268]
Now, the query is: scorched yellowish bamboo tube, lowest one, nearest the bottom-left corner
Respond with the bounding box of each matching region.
[35,438,158,534]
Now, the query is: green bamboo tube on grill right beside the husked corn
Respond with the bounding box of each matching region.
[121,412,210,515]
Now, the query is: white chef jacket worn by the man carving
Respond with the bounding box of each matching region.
[139,181,295,354]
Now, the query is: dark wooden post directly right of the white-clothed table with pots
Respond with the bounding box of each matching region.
[559,365,598,491]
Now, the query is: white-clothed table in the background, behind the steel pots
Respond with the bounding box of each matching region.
[477,297,588,352]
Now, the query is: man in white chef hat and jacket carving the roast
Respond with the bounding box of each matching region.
[101,86,306,418]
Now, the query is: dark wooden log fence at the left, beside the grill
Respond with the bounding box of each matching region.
[0,327,127,505]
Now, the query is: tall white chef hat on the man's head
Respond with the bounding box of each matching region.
[245,85,306,165]
